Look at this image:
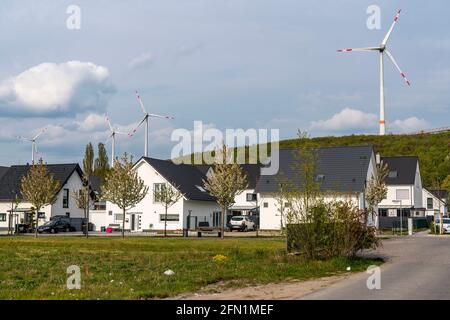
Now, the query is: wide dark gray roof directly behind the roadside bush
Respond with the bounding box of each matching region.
[256,145,373,193]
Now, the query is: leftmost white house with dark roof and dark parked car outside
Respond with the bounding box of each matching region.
[0,164,84,230]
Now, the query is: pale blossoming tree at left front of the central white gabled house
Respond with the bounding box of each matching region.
[102,153,148,237]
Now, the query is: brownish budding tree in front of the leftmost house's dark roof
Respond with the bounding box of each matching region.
[21,159,60,237]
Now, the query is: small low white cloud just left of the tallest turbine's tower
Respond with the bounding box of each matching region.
[310,108,378,132]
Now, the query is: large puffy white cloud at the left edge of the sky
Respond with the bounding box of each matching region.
[0,61,113,116]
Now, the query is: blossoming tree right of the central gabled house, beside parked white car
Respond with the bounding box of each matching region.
[203,145,248,239]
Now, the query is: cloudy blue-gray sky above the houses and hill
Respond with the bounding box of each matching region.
[0,0,450,165]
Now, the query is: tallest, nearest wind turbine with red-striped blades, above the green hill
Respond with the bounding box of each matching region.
[338,10,411,136]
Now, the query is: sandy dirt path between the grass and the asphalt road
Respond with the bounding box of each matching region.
[171,273,352,300]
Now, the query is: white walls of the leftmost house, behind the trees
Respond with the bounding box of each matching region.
[0,171,84,230]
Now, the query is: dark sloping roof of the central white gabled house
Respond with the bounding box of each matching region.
[142,157,215,201]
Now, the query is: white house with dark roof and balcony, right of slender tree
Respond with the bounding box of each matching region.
[378,156,425,222]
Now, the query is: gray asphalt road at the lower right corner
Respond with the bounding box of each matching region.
[297,233,450,300]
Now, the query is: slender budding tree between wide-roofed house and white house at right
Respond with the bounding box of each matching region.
[365,161,389,229]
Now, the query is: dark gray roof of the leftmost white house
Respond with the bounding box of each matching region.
[0,163,83,201]
